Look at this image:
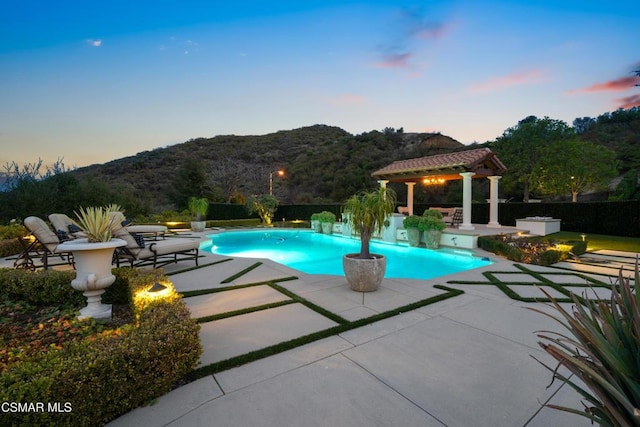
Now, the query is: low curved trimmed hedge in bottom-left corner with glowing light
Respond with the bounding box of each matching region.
[0,269,202,426]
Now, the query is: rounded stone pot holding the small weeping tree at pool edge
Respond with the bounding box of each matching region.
[342,254,387,292]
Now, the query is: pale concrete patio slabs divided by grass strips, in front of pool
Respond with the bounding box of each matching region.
[5,231,633,427]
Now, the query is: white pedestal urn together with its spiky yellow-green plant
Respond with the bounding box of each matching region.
[59,205,127,319]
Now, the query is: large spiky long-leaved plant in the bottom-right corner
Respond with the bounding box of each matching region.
[532,260,640,426]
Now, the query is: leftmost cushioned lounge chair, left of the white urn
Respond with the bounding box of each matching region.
[21,216,73,270]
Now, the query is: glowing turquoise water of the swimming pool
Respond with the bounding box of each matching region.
[202,230,491,279]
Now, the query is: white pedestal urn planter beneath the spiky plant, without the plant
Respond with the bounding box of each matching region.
[58,239,127,319]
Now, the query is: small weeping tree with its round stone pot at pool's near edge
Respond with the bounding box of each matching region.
[342,187,396,292]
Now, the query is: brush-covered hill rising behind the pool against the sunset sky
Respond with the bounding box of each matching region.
[72,125,464,211]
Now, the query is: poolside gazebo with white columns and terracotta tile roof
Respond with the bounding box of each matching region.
[372,148,507,230]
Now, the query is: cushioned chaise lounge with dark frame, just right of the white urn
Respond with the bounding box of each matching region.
[113,212,200,268]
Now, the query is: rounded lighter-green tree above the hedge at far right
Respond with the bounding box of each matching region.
[535,139,617,202]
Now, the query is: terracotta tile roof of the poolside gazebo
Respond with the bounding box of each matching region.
[372,148,507,180]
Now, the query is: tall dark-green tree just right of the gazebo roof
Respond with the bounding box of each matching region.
[490,116,575,202]
